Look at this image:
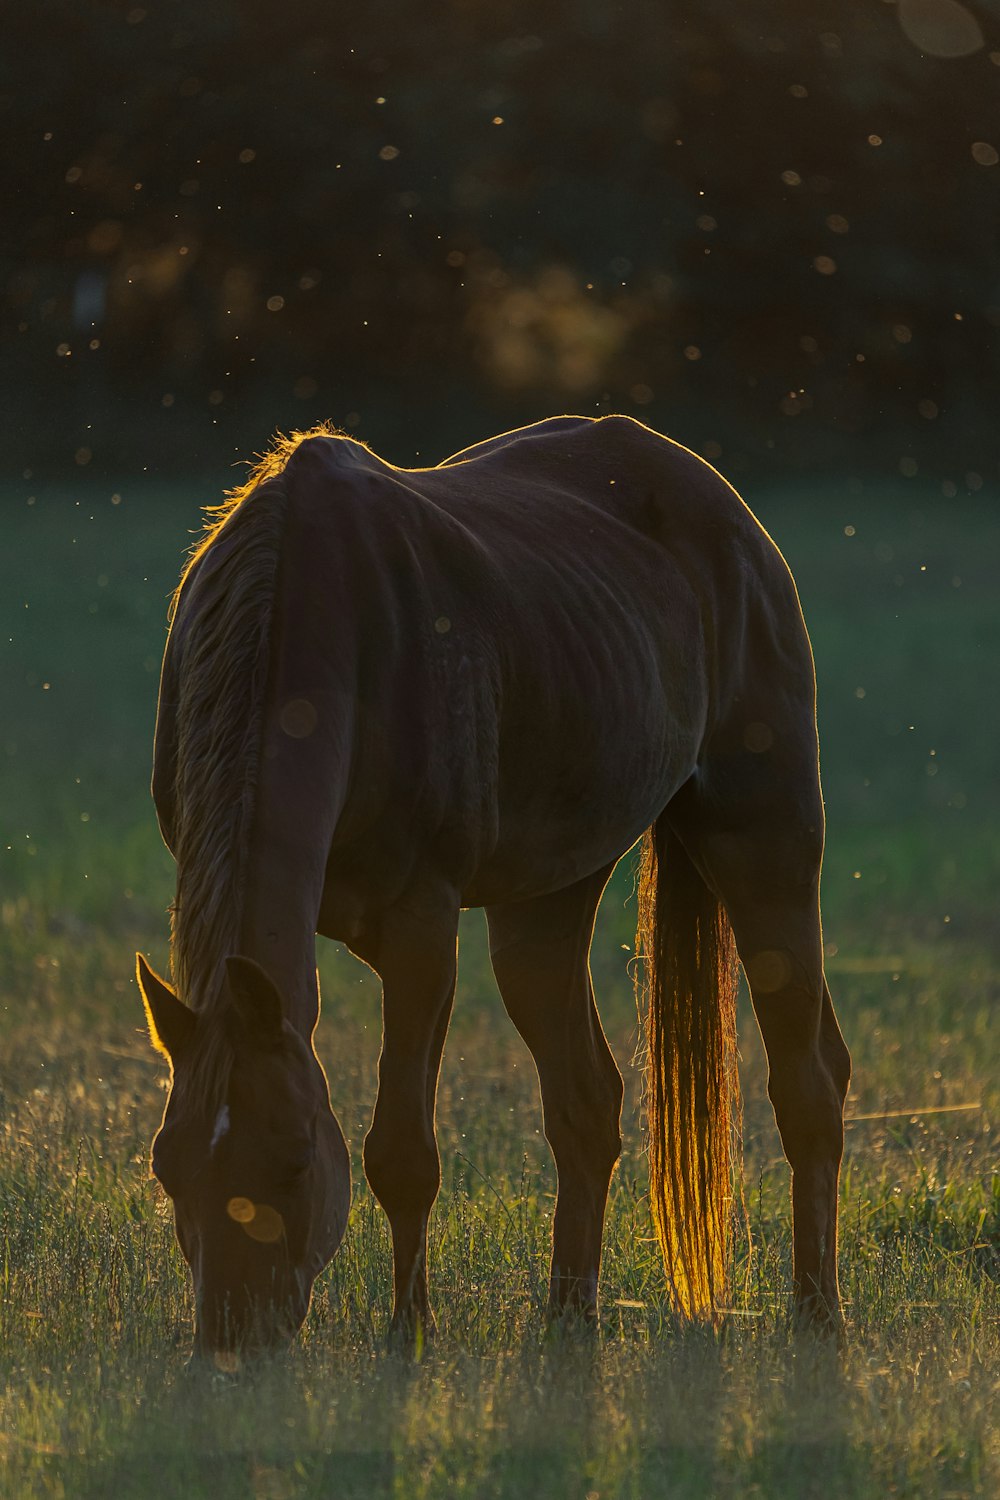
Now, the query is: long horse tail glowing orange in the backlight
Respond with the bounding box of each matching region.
[636,813,739,1320]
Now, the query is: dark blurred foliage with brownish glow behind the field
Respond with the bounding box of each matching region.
[0,0,1000,477]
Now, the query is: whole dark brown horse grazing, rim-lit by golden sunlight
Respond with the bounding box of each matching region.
[139,417,850,1361]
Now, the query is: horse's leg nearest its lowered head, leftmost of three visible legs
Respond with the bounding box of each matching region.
[364,900,457,1338]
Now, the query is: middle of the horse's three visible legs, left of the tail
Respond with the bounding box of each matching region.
[486,870,624,1317]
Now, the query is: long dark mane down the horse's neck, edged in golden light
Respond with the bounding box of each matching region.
[168,425,344,1110]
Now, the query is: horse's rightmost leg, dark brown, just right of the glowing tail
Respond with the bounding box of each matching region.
[670,762,850,1325]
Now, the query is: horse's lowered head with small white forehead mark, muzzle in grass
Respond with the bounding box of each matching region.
[138,956,351,1370]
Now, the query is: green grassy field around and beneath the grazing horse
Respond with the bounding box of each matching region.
[0,465,1000,1500]
